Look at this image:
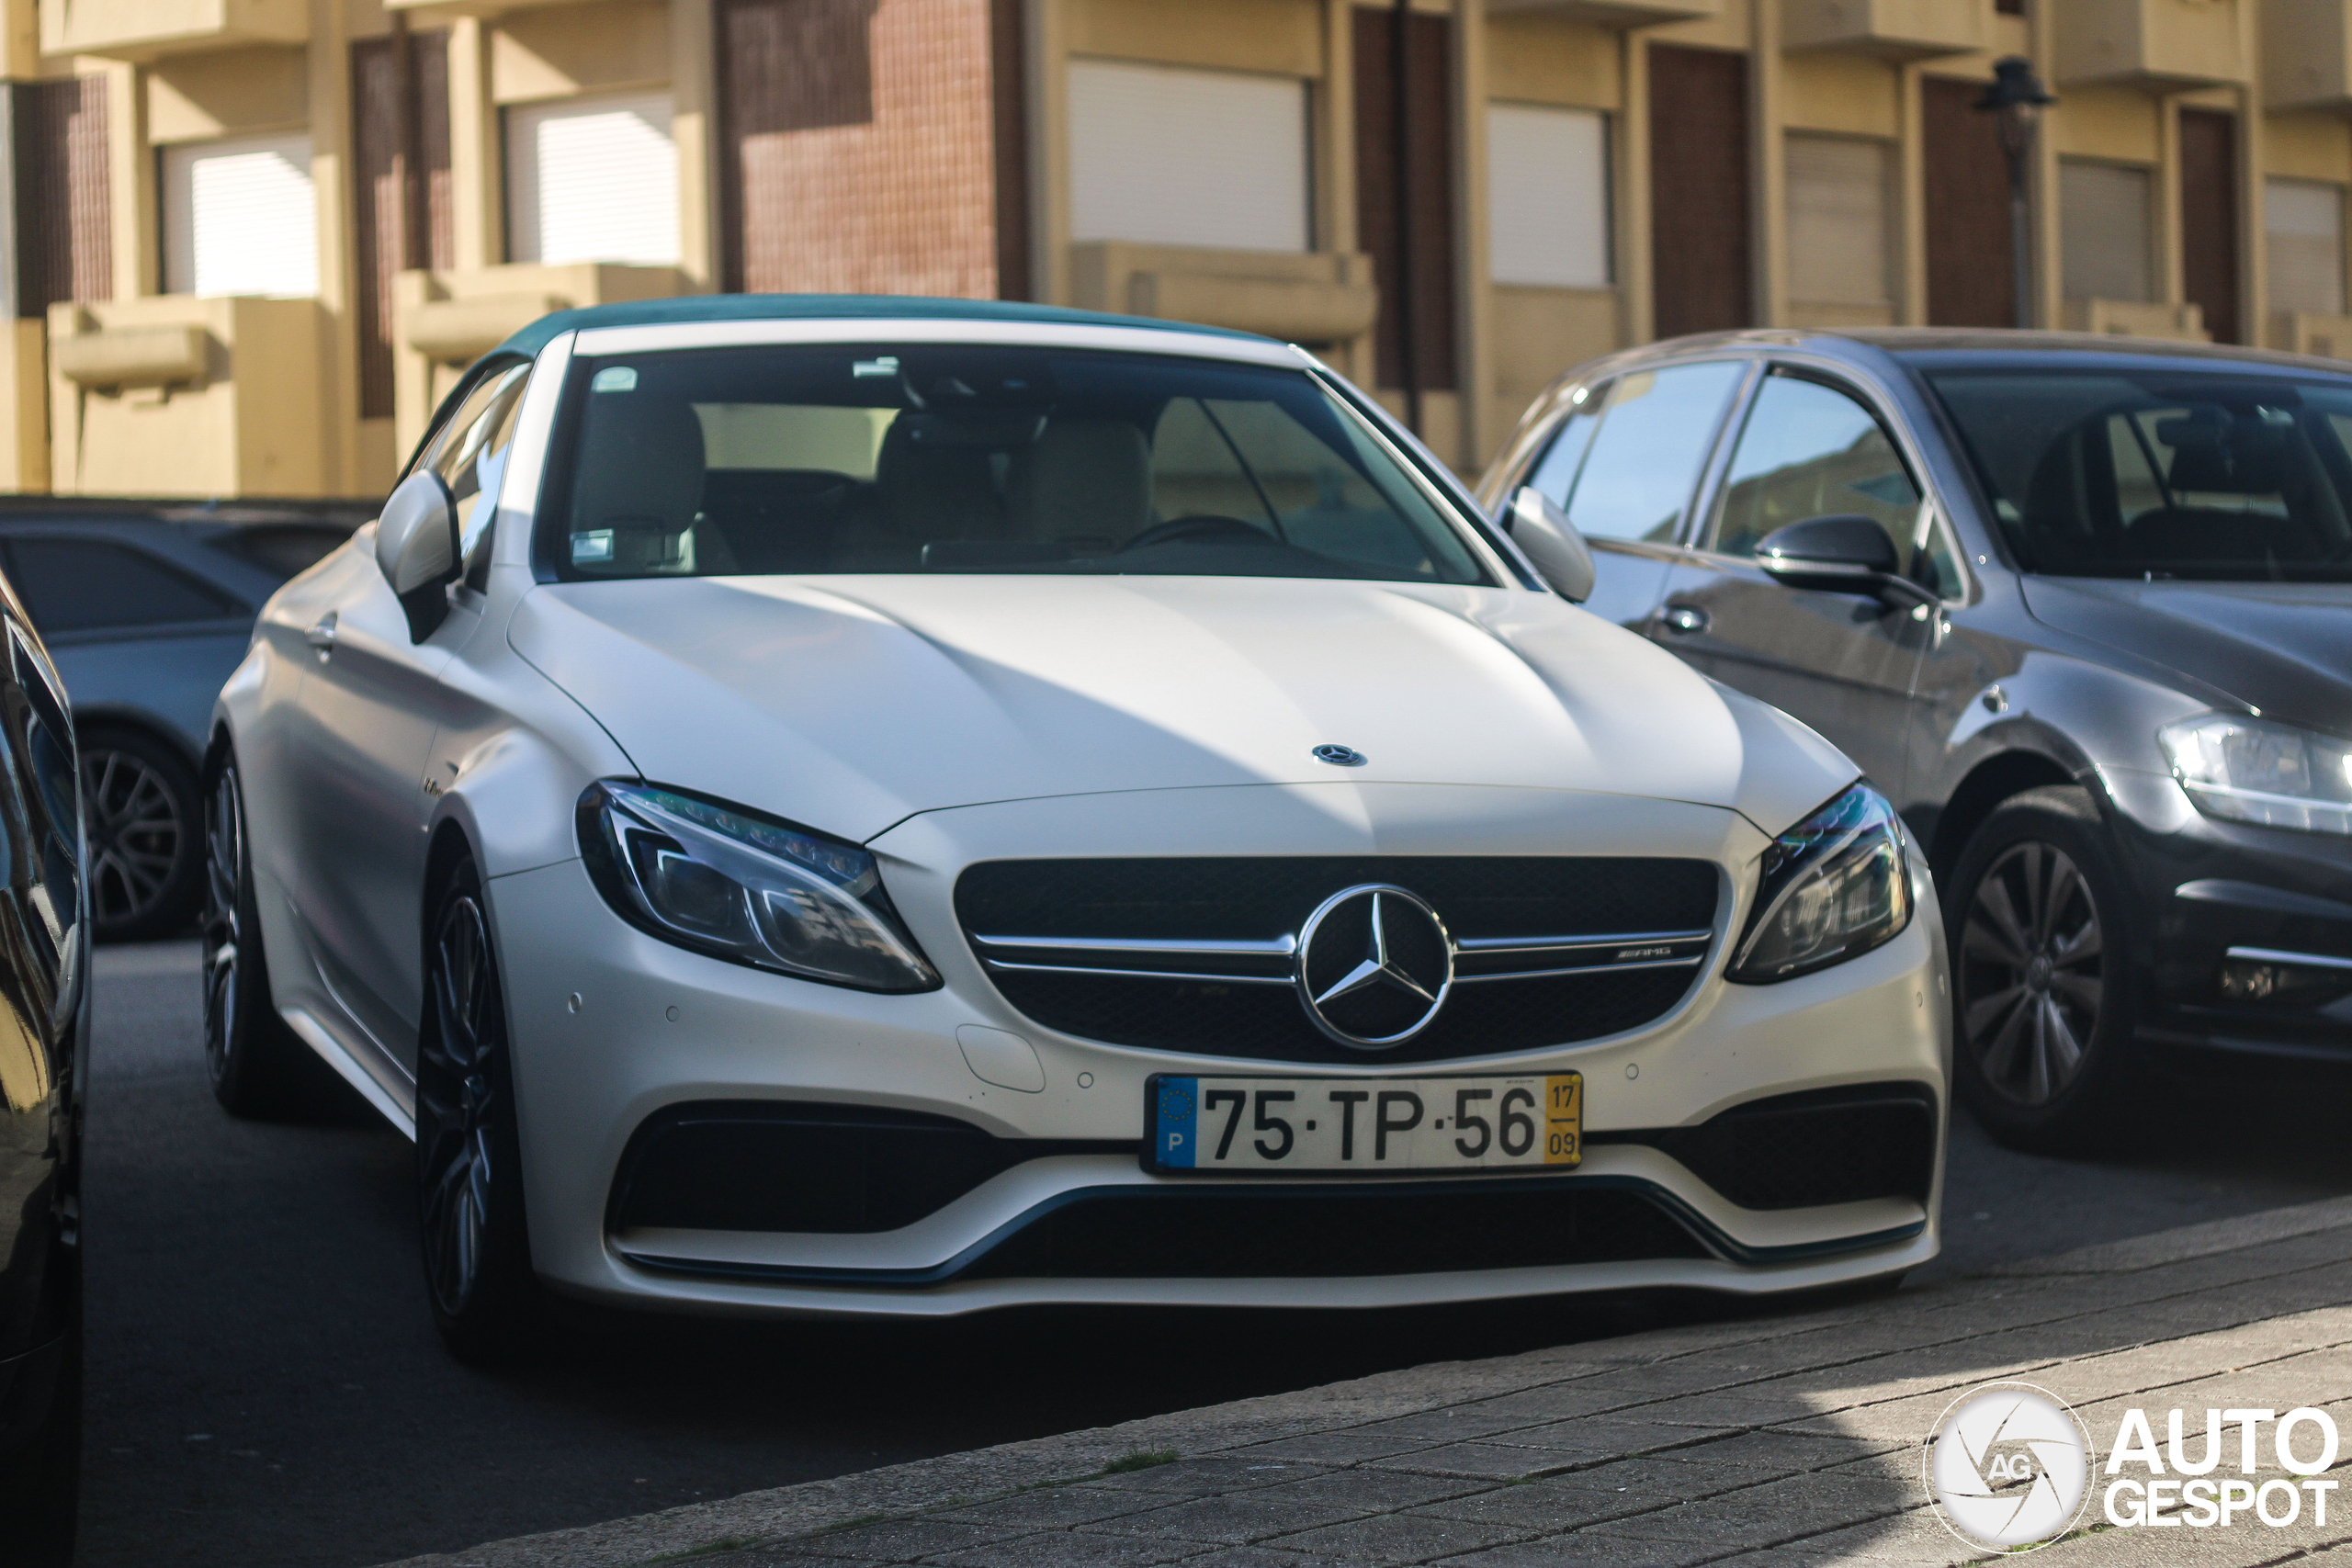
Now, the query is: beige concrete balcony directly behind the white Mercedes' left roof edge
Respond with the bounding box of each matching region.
[393,261,694,458]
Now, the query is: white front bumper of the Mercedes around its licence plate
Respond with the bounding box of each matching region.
[489,790,1950,1316]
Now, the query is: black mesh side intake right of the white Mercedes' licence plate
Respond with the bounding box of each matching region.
[1585,1084,1936,1208]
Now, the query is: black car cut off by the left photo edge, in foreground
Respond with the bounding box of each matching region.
[0,570,89,1568]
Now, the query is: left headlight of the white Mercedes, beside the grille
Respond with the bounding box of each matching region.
[579,781,938,992]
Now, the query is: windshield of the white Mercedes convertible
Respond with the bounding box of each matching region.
[543,344,1488,583]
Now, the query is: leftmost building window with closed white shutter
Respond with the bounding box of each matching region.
[160,134,318,299]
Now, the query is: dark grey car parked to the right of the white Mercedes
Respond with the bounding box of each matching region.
[1484,329,2352,1147]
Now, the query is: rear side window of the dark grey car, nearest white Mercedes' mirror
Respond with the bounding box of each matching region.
[1562,360,1747,543]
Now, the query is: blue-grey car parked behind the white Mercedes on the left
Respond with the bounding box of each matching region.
[0,510,367,941]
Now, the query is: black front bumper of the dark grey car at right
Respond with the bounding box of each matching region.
[2105,773,2352,1067]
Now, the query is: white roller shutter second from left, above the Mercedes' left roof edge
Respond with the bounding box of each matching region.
[505,92,677,265]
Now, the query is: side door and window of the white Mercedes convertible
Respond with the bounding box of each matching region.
[285,367,526,1072]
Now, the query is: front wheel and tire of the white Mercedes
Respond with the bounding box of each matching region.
[416,861,546,1366]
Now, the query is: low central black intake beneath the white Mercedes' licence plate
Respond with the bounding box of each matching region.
[965,1187,1708,1279]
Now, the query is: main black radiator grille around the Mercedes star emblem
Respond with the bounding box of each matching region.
[955,856,1722,1063]
